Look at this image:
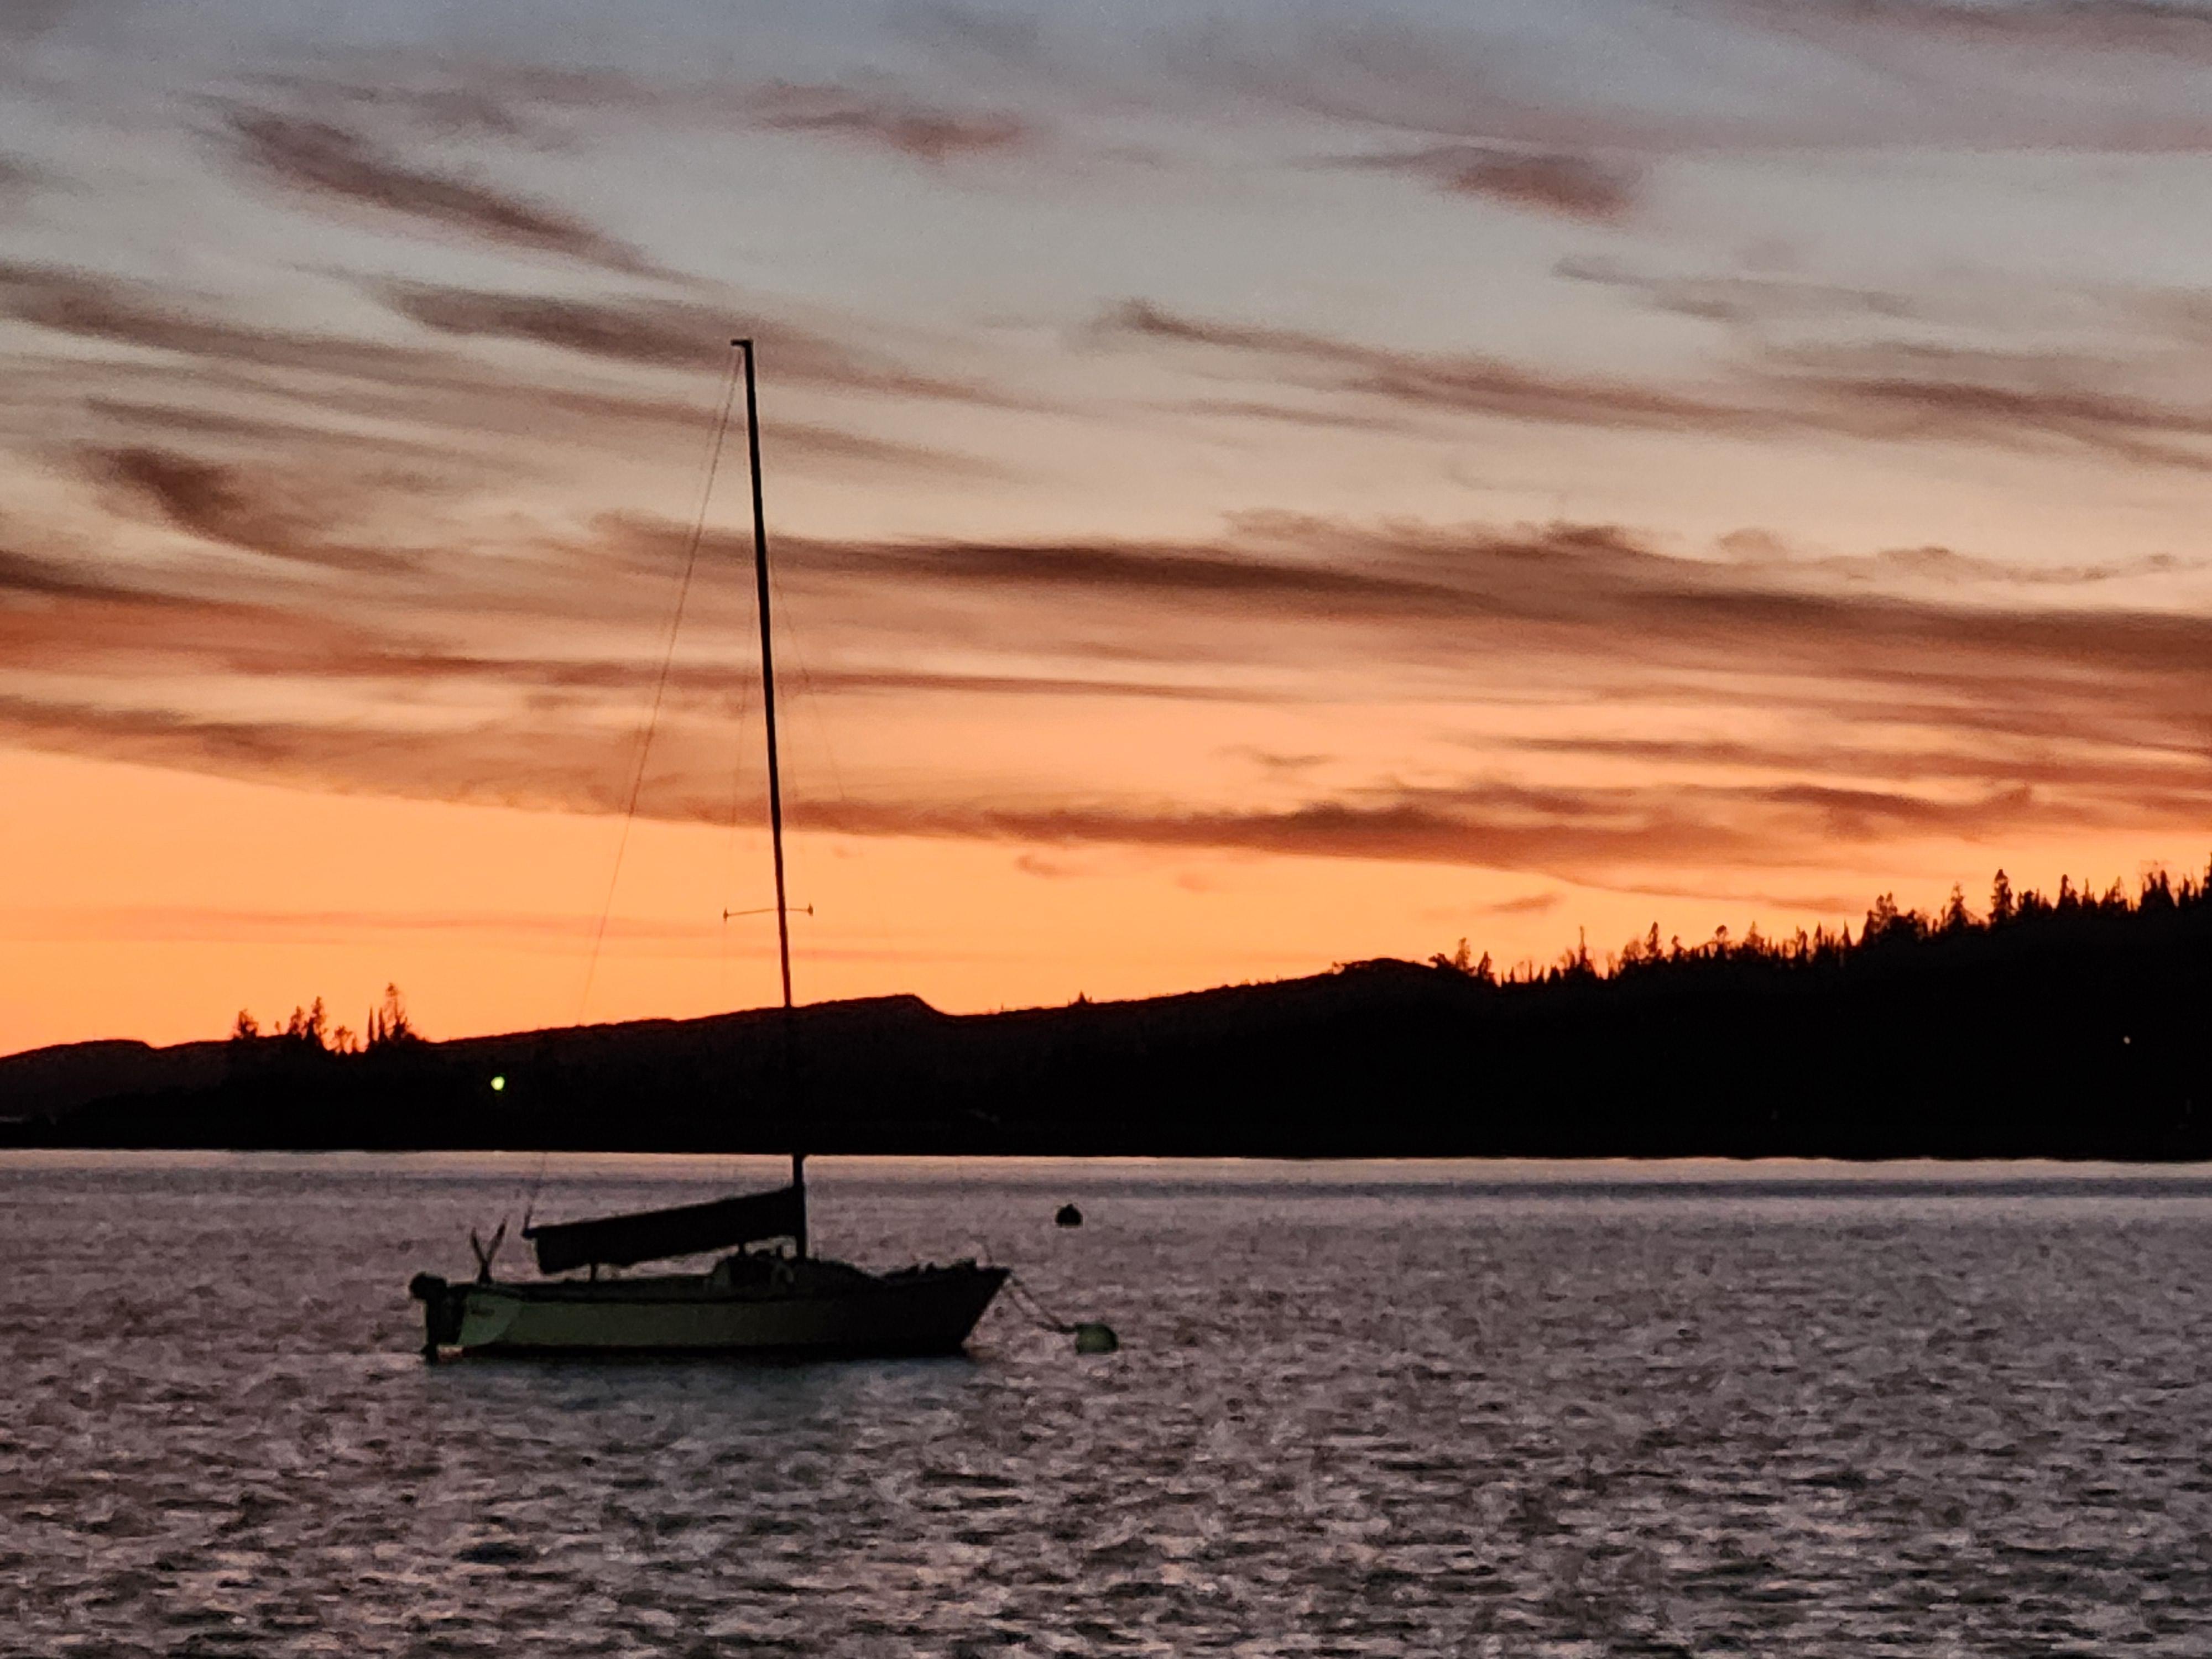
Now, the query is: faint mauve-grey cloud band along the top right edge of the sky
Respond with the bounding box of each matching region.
[1102,0,2212,164]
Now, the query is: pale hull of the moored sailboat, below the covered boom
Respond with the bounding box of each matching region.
[414,1261,1006,1358]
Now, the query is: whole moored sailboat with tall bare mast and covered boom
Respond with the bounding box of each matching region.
[407,338,1006,1360]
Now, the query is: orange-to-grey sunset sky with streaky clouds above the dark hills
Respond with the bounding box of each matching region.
[0,0,2212,1053]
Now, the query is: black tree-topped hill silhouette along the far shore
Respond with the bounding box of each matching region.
[0,872,2212,1159]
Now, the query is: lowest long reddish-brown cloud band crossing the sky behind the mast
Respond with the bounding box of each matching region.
[0,664,2212,880]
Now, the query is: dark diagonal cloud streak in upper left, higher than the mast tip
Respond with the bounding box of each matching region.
[230,111,648,272]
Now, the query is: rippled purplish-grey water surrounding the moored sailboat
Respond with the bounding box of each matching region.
[0,1155,2212,1655]
